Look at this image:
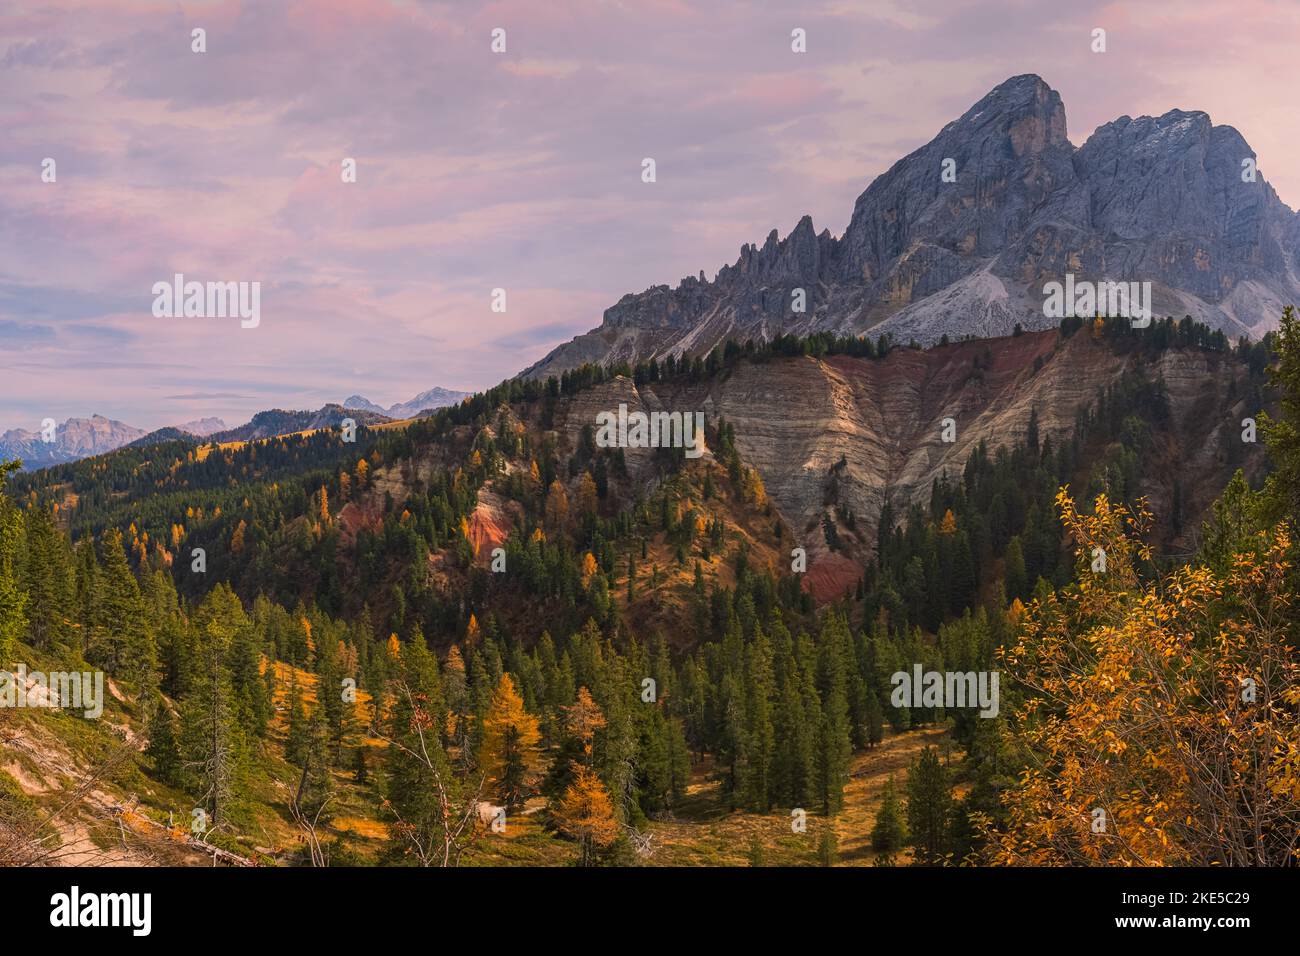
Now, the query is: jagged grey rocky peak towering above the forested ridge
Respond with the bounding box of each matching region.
[524,74,1300,376]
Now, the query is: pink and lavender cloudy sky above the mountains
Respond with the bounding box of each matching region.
[0,0,1300,431]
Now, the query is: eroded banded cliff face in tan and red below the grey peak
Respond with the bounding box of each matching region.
[556,332,1248,595]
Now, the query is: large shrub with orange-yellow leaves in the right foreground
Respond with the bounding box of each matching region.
[985,489,1300,866]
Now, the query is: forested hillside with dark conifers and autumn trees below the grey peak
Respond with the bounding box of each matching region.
[0,313,1300,865]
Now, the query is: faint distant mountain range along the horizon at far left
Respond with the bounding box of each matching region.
[0,388,469,471]
